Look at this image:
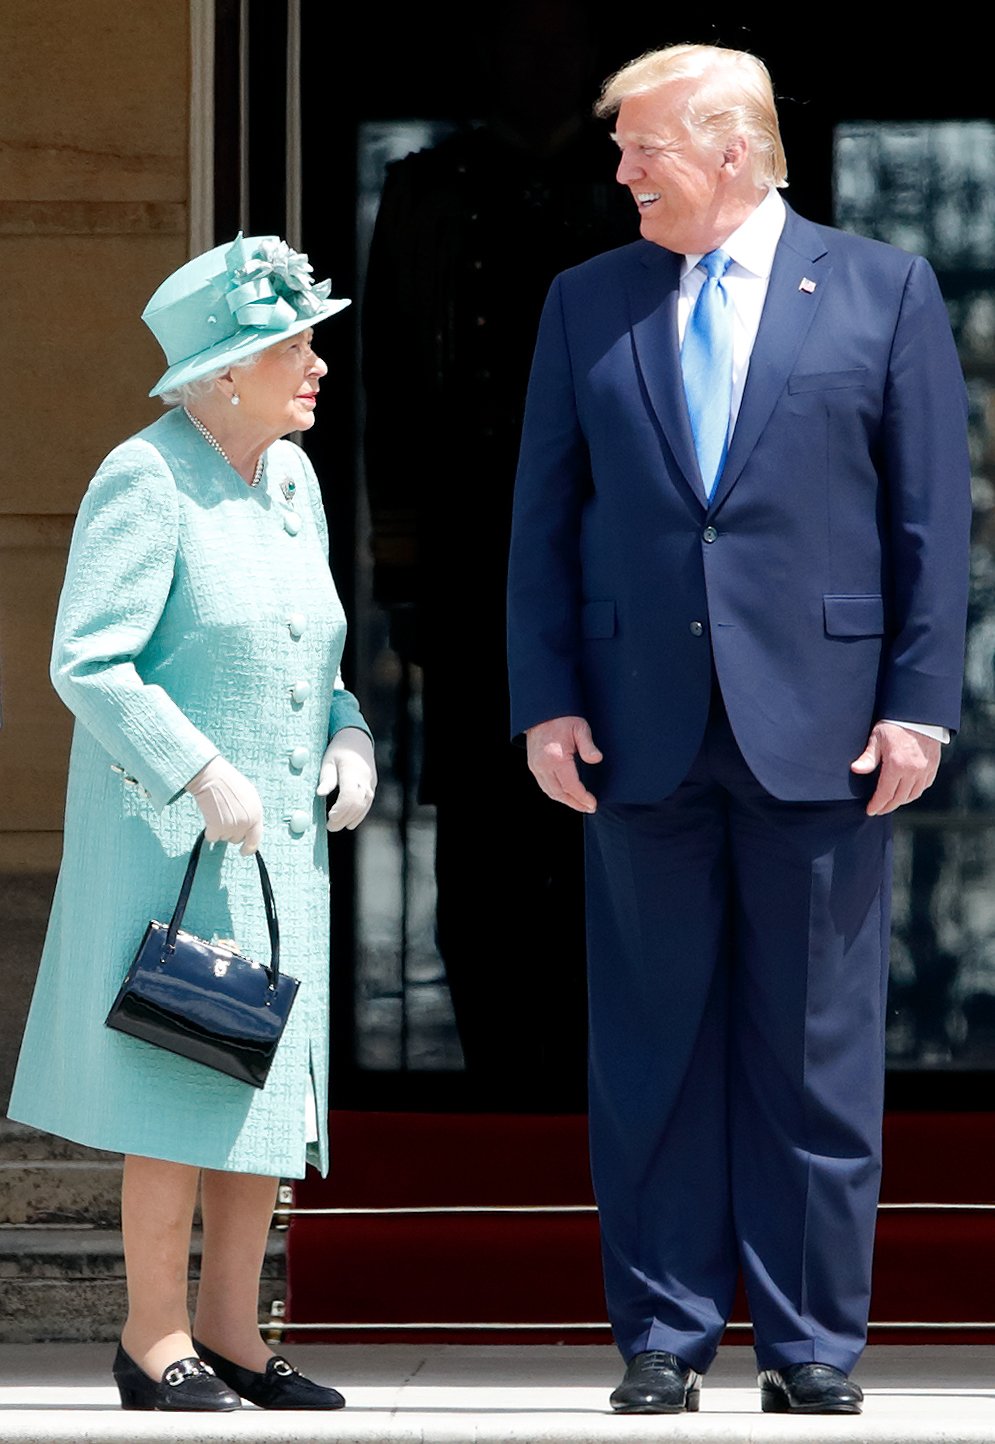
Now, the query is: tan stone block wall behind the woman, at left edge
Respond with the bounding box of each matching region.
[0,0,191,1110]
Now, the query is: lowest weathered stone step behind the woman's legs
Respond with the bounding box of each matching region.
[0,1227,286,1343]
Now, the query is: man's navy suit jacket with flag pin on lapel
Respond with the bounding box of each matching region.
[508,209,970,801]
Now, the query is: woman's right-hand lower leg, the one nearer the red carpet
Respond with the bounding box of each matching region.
[194,1168,280,1372]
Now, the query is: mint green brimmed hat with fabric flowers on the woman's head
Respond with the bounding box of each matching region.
[142,231,349,396]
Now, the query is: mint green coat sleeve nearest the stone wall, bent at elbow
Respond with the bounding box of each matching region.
[51,439,218,810]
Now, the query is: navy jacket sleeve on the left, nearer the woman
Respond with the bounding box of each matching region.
[508,279,591,735]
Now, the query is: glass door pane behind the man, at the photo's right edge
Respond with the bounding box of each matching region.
[833,120,995,1071]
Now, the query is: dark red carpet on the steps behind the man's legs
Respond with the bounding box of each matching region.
[286,1112,995,1343]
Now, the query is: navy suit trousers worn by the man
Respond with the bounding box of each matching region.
[585,689,891,1372]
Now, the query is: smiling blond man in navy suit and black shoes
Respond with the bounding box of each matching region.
[508,46,970,1414]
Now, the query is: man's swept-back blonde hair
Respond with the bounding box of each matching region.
[595,45,787,186]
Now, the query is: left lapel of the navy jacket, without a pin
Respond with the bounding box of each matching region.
[627,243,706,507]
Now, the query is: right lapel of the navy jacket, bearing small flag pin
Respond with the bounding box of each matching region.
[712,208,832,510]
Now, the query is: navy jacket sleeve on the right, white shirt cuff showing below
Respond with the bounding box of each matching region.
[878,257,970,732]
